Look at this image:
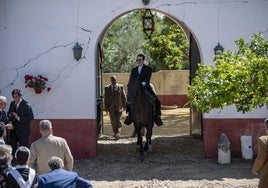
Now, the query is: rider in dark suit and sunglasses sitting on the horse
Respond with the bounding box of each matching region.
[127,54,163,126]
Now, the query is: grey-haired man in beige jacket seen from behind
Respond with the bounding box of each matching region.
[29,120,73,174]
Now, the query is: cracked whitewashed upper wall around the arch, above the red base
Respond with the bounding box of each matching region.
[0,0,268,119]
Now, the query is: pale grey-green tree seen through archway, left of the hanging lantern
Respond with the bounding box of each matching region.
[102,11,144,73]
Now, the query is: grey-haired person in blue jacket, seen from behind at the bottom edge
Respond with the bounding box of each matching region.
[38,156,92,188]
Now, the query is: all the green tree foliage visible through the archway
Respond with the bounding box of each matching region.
[102,10,189,73]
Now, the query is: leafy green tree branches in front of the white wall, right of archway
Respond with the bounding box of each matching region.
[188,33,268,113]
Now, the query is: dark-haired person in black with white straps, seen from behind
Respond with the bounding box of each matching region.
[6,146,38,188]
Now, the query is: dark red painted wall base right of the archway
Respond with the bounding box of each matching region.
[203,119,266,158]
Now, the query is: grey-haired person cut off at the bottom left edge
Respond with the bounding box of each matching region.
[0,144,12,188]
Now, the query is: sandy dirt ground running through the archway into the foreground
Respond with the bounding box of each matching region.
[74,109,258,188]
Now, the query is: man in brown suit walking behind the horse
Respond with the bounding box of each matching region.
[104,75,126,139]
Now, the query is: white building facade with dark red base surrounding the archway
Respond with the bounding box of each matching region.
[0,0,268,158]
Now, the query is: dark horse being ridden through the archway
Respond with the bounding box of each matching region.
[127,77,154,157]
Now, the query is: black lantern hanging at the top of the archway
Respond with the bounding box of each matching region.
[142,9,154,39]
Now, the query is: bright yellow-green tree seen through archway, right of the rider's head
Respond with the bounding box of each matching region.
[143,18,189,70]
